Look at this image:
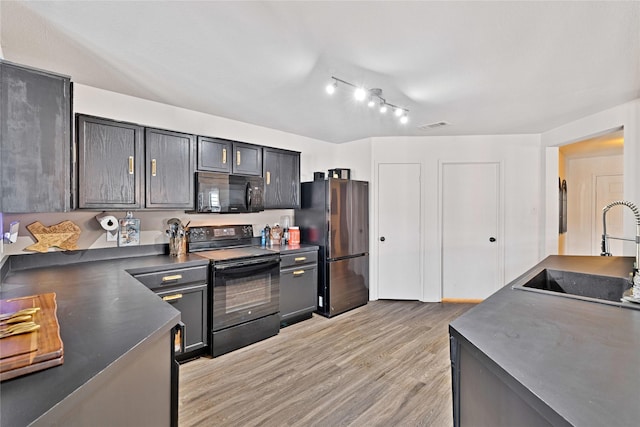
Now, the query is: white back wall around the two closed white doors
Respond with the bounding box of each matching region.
[371,135,544,301]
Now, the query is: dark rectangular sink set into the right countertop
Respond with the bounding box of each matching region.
[513,269,640,310]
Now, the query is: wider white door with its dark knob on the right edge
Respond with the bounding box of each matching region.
[441,163,501,300]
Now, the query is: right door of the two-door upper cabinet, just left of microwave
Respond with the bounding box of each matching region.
[145,128,196,209]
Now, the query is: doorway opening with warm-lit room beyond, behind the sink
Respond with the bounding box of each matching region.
[558,129,624,255]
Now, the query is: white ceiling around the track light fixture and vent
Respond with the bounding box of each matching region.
[0,0,640,142]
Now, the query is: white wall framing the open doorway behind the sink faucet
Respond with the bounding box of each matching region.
[540,99,640,256]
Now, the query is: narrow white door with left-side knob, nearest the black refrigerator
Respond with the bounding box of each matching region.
[376,163,422,300]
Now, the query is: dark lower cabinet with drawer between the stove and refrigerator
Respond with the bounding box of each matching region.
[280,250,318,327]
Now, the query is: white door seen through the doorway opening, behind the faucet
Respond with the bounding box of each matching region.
[591,175,628,256]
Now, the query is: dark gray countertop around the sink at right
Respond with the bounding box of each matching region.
[450,256,640,426]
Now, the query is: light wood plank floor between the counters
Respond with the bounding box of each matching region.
[179,301,474,427]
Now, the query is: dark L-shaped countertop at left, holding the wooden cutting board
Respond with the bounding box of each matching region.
[0,251,207,426]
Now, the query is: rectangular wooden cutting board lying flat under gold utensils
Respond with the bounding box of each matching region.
[0,293,64,381]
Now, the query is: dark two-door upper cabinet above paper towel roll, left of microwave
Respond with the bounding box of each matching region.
[77,114,196,210]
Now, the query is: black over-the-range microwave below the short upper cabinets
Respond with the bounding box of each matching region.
[196,172,264,213]
